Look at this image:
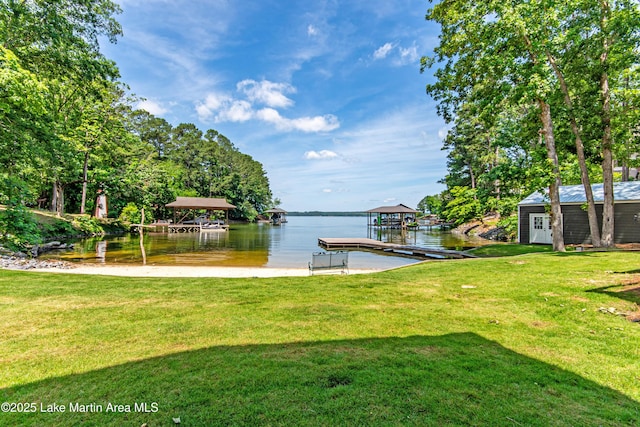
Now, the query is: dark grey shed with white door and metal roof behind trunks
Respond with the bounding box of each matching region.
[518,181,640,245]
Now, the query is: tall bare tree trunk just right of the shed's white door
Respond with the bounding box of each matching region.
[538,99,565,252]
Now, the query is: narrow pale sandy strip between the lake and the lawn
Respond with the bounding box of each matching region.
[30,264,382,277]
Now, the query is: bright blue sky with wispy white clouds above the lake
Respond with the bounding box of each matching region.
[103,0,446,211]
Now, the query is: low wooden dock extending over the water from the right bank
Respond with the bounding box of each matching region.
[318,237,477,259]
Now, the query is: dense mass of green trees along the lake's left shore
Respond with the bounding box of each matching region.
[0,0,271,226]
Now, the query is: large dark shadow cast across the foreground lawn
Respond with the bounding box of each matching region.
[0,333,640,426]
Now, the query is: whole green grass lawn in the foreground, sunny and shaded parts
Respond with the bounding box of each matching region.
[0,252,640,427]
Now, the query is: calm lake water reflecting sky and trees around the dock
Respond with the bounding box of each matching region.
[50,216,484,268]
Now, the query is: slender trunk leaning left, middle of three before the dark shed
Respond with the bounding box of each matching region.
[546,51,602,248]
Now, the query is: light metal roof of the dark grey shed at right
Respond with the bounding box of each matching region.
[518,181,640,205]
